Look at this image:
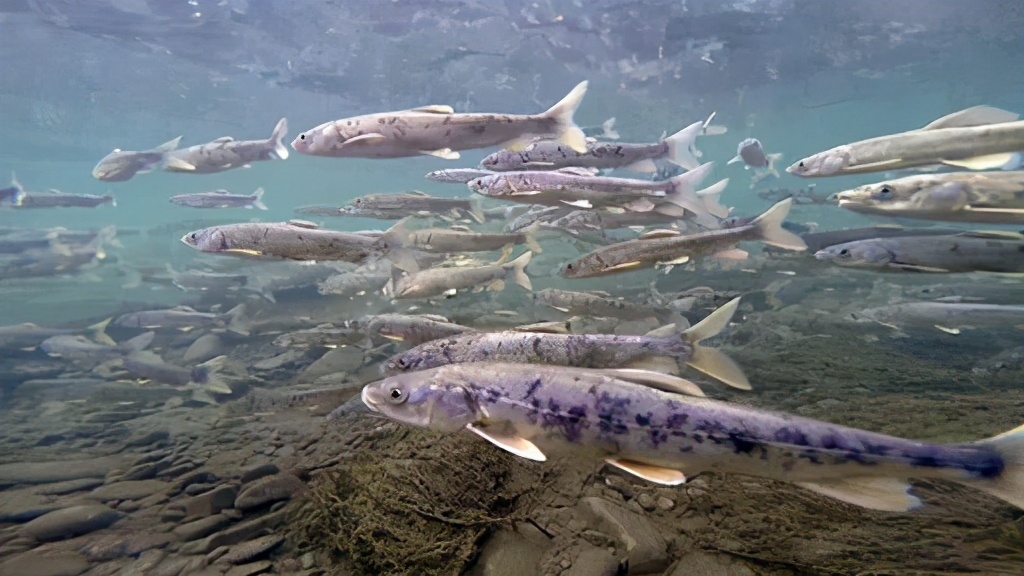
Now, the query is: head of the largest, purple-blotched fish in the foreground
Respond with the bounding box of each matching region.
[361,367,482,431]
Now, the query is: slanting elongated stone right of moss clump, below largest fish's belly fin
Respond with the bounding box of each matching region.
[581,496,669,574]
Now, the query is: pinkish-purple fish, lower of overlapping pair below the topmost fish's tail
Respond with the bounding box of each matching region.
[467,162,728,223]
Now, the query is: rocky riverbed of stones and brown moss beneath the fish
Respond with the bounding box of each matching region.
[0,303,1024,576]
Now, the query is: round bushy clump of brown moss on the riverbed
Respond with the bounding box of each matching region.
[292,429,524,576]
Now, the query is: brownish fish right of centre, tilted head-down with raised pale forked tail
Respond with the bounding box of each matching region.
[559,199,807,278]
